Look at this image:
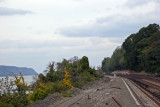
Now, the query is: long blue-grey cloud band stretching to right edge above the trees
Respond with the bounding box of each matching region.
[59,11,160,37]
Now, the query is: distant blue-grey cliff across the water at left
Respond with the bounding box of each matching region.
[0,65,38,77]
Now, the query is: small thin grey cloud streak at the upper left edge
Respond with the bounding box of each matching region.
[0,7,32,16]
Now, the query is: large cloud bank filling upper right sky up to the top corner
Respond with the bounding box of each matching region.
[58,0,160,37]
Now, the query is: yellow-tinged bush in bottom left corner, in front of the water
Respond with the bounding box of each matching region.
[0,75,29,107]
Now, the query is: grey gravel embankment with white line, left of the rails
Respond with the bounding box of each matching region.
[29,76,159,107]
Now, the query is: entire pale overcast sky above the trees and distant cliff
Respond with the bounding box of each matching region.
[0,0,160,73]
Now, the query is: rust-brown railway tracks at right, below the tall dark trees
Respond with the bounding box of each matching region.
[121,75,160,106]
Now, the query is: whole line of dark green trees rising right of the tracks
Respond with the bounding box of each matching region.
[102,24,160,73]
